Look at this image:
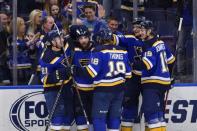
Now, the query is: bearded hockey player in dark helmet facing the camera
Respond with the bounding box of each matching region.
[70,25,94,131]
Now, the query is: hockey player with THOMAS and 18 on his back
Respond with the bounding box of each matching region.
[75,30,131,131]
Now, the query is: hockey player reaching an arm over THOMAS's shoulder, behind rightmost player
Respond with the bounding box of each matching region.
[112,18,144,131]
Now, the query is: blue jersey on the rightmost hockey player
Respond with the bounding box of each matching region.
[141,40,175,85]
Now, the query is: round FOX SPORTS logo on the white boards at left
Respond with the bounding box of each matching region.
[9,91,48,131]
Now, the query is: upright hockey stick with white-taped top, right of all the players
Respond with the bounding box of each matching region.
[164,17,183,111]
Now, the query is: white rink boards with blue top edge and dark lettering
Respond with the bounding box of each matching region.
[0,84,197,131]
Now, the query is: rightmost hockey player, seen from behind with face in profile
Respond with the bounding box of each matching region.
[133,21,175,131]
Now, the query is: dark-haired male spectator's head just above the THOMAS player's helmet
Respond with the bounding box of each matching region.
[107,17,122,35]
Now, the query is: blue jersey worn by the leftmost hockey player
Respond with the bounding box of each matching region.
[39,44,71,89]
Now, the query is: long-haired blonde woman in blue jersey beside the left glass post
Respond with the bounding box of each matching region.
[9,17,33,84]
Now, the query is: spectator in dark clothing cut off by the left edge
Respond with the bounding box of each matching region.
[0,12,10,84]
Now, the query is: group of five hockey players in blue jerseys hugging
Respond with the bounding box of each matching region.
[39,18,175,131]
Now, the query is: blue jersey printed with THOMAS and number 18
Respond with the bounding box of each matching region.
[85,45,131,87]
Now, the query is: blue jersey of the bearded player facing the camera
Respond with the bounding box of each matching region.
[72,47,93,91]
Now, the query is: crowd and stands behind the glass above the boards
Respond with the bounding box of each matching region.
[0,0,192,85]
